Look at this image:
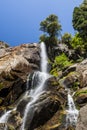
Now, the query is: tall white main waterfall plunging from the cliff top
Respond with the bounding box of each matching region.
[21,42,49,130]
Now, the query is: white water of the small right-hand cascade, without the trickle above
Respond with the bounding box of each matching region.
[66,91,78,126]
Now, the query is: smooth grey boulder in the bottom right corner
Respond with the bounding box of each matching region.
[76,105,87,130]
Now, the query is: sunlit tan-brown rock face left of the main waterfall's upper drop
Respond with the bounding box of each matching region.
[0,43,40,106]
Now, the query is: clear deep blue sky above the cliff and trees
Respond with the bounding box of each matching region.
[0,0,83,46]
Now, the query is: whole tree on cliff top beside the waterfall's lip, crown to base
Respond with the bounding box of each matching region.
[40,14,61,58]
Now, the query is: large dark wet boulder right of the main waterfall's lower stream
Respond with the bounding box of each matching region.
[25,77,66,130]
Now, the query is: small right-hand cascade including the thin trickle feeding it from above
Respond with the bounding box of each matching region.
[60,81,79,129]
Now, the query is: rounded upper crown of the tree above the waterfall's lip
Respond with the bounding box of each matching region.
[40,14,61,37]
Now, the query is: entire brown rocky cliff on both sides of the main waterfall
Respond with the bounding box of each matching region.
[0,43,87,130]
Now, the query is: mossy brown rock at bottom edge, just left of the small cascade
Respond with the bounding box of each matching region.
[35,110,66,130]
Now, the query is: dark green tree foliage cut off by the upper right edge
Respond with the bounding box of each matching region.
[72,0,87,41]
